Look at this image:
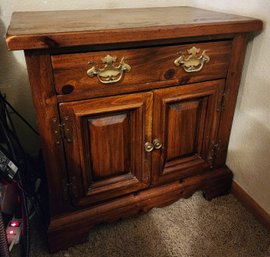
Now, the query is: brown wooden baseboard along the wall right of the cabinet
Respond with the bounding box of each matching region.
[232,181,270,231]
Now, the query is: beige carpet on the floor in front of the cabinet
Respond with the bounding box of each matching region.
[15,193,270,257]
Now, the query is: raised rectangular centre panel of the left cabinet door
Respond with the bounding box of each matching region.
[88,113,130,180]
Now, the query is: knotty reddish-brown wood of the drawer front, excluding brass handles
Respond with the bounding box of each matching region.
[51,40,231,100]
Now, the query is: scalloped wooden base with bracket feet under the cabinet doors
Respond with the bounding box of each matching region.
[48,167,232,252]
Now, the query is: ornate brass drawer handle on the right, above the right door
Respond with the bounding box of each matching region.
[174,46,210,72]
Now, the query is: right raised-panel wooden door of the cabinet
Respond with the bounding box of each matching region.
[152,80,224,184]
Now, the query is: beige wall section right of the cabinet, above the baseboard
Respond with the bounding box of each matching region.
[192,0,270,214]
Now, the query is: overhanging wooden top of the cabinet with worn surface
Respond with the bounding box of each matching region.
[6,7,262,50]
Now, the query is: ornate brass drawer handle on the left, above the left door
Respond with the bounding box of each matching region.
[87,55,131,84]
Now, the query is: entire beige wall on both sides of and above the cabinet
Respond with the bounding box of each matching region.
[0,0,270,214]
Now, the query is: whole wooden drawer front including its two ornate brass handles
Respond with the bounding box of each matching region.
[51,41,231,98]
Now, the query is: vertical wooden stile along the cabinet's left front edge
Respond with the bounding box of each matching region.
[25,51,69,216]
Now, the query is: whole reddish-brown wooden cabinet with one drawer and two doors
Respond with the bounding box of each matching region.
[7,7,262,251]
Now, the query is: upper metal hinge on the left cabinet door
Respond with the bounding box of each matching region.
[51,116,72,145]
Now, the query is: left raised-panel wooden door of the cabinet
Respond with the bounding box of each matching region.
[60,93,153,206]
